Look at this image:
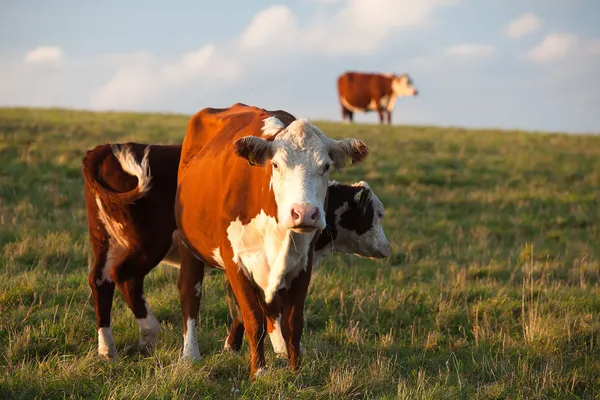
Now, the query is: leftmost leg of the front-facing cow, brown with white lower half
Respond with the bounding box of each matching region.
[177,242,204,361]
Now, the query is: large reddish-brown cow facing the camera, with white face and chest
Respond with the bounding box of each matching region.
[175,104,368,378]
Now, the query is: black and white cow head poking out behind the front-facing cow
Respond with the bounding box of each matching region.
[316,181,392,259]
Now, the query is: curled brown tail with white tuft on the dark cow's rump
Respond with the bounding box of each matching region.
[82,144,152,204]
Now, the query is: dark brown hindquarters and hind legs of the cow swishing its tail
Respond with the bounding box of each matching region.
[82,143,181,358]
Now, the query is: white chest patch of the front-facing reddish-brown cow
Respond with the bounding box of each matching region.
[227,210,314,303]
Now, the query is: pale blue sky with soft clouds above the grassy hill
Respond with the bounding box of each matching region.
[0,0,600,133]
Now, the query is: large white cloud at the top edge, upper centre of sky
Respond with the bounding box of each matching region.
[238,0,457,56]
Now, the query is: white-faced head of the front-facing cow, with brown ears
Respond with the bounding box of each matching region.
[235,117,368,233]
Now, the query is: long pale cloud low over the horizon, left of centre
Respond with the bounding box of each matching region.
[91,44,240,109]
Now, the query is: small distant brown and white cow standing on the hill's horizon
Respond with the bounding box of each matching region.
[337,72,419,124]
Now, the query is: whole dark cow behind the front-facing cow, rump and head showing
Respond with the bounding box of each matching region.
[82,141,391,358]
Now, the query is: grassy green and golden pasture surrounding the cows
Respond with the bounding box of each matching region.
[0,109,600,399]
